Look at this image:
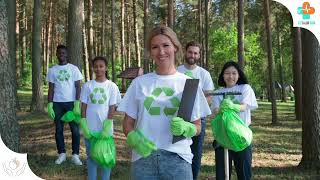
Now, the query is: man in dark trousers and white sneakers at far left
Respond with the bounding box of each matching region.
[46,45,83,165]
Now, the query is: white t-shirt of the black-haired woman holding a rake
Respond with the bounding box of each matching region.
[212,84,258,126]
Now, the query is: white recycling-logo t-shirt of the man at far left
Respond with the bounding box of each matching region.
[46,63,83,102]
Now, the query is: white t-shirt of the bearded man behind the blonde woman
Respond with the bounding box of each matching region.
[177,65,214,91]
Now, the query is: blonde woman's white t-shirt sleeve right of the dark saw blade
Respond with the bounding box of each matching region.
[191,87,211,122]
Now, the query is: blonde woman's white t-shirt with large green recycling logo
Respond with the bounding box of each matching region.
[118,72,211,163]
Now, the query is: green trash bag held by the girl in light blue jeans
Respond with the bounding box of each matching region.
[90,134,116,168]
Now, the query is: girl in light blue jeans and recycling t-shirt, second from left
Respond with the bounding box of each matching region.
[80,56,121,180]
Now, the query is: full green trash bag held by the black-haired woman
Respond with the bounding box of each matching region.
[211,110,252,152]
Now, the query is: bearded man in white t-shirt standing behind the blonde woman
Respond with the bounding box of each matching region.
[177,41,214,179]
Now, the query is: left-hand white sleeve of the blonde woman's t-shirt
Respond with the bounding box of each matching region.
[117,80,139,119]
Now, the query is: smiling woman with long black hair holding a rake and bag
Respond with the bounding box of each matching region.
[212,61,258,180]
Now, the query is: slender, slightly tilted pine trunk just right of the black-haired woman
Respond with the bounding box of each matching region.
[264,0,278,124]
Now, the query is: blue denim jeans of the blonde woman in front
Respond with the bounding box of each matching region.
[131,149,192,180]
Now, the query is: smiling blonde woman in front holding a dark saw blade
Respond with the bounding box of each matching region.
[118,26,211,180]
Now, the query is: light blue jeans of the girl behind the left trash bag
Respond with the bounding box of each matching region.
[84,139,111,180]
